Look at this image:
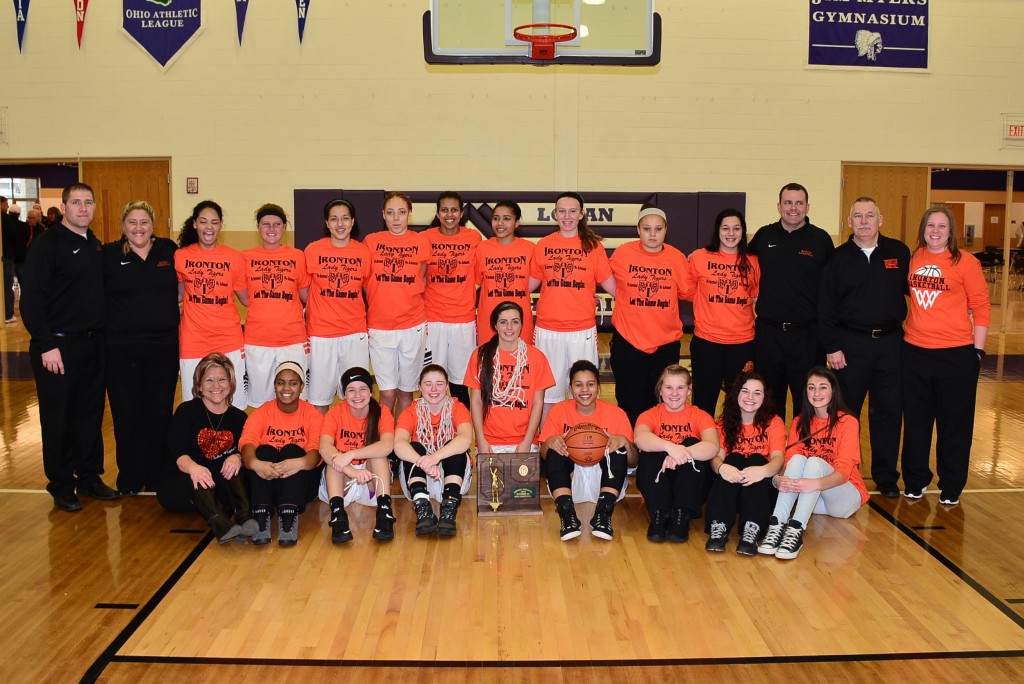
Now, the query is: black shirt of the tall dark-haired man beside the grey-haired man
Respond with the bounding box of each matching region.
[750,221,835,323]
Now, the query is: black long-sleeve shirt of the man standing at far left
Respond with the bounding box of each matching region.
[22,223,103,352]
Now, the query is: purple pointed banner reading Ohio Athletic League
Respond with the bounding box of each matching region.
[121,0,203,67]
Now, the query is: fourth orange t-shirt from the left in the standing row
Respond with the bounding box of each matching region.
[364,230,430,330]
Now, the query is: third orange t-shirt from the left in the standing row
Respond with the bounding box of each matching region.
[305,238,370,337]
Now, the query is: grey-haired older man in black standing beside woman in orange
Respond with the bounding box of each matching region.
[818,197,910,499]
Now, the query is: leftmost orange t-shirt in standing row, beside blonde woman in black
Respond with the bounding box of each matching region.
[174,245,246,358]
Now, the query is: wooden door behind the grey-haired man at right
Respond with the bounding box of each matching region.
[840,164,931,248]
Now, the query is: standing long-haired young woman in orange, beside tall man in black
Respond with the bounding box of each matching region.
[686,209,761,416]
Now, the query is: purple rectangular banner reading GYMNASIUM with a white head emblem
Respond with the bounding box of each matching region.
[807,0,928,69]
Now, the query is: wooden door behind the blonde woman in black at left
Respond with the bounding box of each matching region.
[79,159,172,243]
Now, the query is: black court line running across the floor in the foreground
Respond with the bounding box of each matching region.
[103,650,1024,669]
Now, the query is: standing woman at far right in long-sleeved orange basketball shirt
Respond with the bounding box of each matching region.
[902,207,991,506]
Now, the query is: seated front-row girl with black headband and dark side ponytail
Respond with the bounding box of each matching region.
[319,367,394,544]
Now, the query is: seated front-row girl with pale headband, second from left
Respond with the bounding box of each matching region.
[239,361,324,546]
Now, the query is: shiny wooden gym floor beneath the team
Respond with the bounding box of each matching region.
[0,295,1024,683]
